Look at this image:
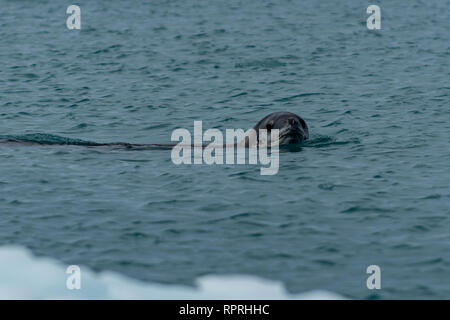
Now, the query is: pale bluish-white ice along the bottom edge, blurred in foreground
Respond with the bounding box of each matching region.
[0,246,343,300]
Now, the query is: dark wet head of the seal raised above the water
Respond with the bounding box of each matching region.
[253,111,309,145]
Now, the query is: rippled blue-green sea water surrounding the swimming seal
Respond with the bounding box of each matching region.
[0,0,450,299]
